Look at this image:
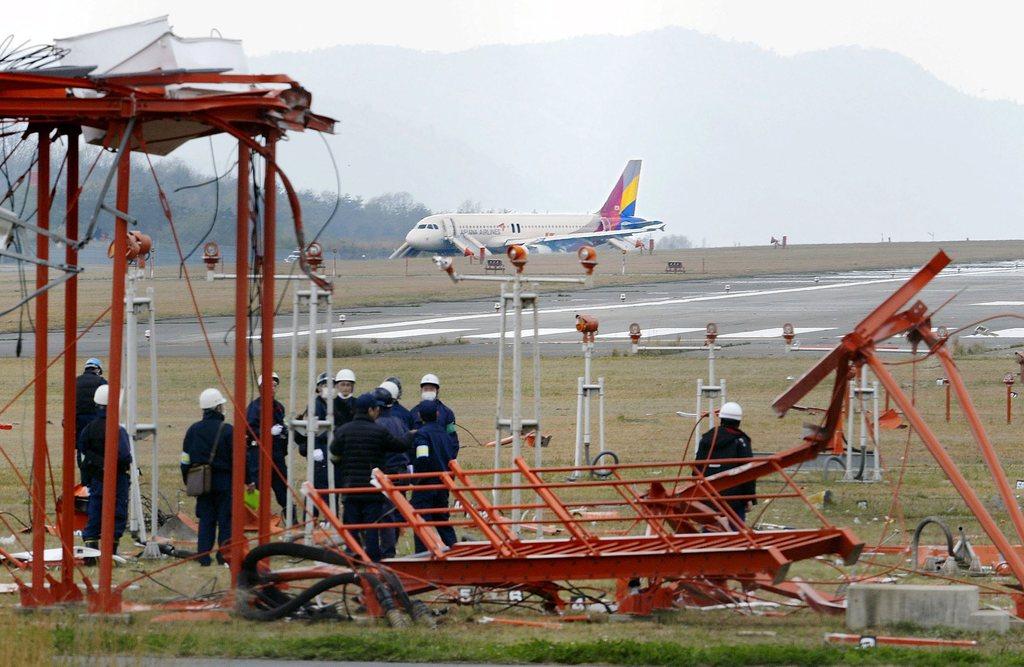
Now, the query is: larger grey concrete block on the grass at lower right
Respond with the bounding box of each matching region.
[846,584,979,630]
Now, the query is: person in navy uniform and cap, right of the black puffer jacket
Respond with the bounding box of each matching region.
[412,401,457,552]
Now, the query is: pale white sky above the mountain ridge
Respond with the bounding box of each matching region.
[12,0,1024,102]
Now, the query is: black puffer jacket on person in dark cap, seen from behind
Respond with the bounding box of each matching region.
[331,414,413,488]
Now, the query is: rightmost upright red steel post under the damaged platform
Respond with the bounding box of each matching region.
[258,134,280,544]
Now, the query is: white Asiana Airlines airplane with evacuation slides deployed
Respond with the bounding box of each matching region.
[390,160,665,259]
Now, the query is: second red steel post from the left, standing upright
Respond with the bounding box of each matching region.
[58,127,82,600]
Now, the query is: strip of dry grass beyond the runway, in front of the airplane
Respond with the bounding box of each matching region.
[0,241,1024,332]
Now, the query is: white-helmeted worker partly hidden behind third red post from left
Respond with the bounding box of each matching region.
[76,384,132,553]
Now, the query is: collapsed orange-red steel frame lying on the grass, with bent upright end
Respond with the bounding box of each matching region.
[237,252,1024,615]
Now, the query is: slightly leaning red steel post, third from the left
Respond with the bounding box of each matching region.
[90,129,131,614]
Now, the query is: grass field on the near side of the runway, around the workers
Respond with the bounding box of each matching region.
[0,349,1024,665]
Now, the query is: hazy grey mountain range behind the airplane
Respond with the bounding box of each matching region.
[214,29,1024,245]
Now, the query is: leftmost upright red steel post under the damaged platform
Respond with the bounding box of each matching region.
[26,127,50,606]
